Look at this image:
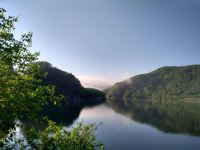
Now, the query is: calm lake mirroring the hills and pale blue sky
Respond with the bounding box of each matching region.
[14,100,200,150]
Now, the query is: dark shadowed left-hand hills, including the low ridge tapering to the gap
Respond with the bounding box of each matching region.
[37,62,105,104]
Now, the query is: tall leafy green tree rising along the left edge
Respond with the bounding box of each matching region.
[0,8,59,143]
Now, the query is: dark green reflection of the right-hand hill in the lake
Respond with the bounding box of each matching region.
[107,100,200,136]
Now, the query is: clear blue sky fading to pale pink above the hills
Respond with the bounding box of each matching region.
[0,0,200,89]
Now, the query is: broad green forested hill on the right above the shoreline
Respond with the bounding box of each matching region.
[106,65,200,100]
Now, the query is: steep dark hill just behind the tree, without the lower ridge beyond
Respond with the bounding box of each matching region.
[37,62,82,103]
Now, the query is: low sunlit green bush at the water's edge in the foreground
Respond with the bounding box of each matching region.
[27,121,104,150]
